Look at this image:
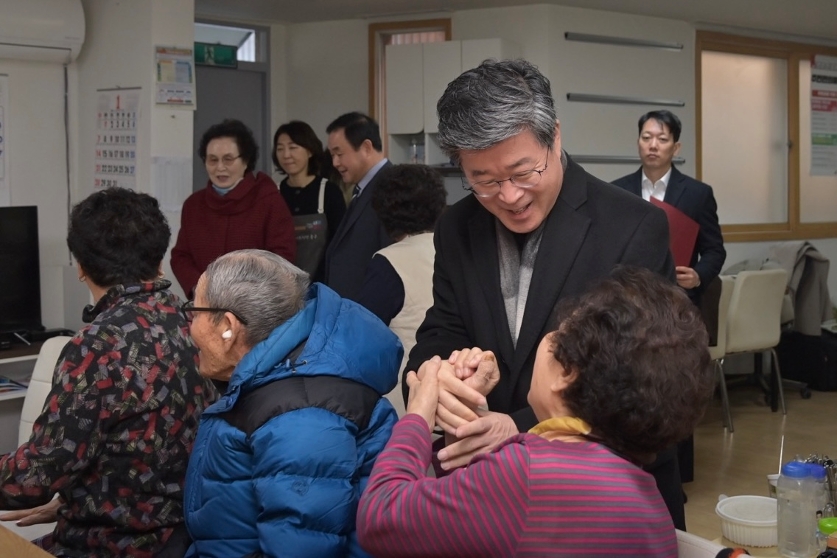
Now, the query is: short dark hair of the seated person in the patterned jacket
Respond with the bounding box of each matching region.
[67,188,171,287]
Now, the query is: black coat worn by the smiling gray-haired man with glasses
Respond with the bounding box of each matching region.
[403,159,685,529]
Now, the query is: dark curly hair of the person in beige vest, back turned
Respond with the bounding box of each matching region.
[371,165,447,240]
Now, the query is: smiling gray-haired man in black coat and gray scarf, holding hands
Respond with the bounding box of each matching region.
[404,60,685,528]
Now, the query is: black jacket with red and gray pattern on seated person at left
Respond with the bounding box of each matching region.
[0,280,217,557]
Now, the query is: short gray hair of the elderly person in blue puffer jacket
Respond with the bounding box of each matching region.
[204,250,309,347]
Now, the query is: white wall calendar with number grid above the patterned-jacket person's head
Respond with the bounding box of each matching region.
[93,87,140,190]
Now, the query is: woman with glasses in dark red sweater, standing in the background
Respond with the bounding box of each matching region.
[171,120,296,298]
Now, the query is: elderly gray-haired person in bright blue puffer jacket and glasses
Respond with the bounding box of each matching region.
[184,250,402,558]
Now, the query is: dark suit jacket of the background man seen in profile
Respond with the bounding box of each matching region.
[325,162,392,300]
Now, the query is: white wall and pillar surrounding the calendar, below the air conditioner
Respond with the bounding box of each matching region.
[0,0,194,329]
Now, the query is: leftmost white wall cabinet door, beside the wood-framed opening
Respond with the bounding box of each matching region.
[386,44,424,134]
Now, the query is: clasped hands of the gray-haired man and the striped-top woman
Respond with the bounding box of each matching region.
[406,347,518,470]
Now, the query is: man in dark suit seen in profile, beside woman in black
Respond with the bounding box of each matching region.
[325,112,392,300]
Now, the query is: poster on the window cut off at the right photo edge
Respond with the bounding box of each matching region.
[811,54,837,176]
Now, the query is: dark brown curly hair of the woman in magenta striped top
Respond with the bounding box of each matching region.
[550,266,715,463]
